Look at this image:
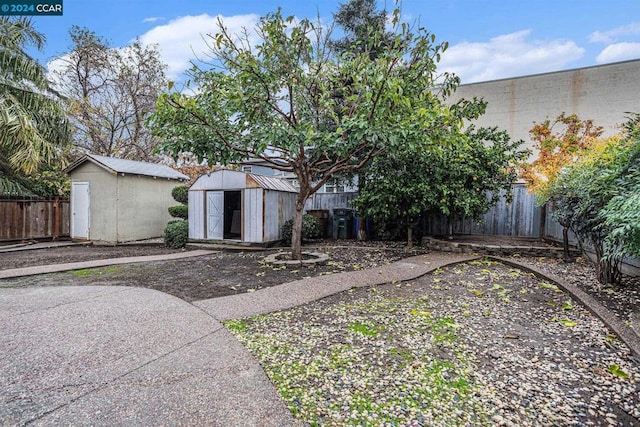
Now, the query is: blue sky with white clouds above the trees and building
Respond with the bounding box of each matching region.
[27,0,640,83]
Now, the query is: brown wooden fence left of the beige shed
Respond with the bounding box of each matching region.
[0,198,70,241]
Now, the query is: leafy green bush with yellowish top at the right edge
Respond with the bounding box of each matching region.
[549,116,640,283]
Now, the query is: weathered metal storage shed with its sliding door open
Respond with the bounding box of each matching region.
[189,169,298,243]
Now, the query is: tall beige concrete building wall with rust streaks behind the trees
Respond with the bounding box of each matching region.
[451,60,640,155]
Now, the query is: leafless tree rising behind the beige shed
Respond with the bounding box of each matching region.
[55,26,166,160]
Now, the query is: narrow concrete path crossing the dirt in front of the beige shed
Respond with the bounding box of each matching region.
[0,250,215,279]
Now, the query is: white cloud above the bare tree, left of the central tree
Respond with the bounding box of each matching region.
[140,14,259,79]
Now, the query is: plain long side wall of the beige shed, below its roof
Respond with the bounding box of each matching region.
[117,175,176,242]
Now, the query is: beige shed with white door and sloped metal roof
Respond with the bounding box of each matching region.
[65,154,189,243]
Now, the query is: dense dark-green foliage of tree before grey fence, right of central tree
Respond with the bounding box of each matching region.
[354,126,528,242]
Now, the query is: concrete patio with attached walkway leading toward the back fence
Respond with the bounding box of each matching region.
[0,251,640,426]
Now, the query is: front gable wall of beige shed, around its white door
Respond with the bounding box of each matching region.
[70,162,117,242]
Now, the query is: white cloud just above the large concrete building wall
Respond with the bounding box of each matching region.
[438,30,585,83]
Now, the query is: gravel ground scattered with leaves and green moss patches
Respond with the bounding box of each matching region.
[226,260,640,426]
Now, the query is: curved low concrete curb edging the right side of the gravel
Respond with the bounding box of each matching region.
[496,257,640,358]
